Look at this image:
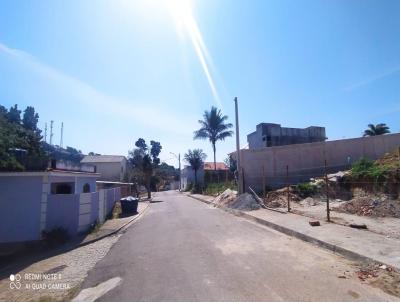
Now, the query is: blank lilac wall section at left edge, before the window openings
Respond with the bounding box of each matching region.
[0,176,43,242]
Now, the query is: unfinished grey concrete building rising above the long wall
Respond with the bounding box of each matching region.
[247,123,326,149]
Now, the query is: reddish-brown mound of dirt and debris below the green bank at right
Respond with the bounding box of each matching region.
[335,196,400,218]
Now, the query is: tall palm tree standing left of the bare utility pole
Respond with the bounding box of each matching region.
[194,106,233,170]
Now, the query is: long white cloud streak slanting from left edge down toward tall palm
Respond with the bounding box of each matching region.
[0,43,197,136]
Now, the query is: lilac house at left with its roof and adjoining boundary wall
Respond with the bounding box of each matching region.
[0,160,129,247]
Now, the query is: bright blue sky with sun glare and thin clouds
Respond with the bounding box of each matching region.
[0,0,400,163]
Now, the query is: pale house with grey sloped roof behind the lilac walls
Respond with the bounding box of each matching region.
[81,155,127,181]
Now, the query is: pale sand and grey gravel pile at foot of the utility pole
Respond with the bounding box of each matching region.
[213,189,260,211]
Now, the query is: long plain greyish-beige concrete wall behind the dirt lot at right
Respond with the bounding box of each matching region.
[233,133,400,189]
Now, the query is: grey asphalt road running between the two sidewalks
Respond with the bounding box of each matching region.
[79,191,398,302]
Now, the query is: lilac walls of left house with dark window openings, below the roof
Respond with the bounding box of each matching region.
[0,170,99,243]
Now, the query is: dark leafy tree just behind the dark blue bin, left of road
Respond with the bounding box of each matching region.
[129,138,162,198]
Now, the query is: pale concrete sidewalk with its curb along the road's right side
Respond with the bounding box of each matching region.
[188,194,400,270]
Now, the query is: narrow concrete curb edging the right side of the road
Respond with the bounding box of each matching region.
[187,194,400,269]
